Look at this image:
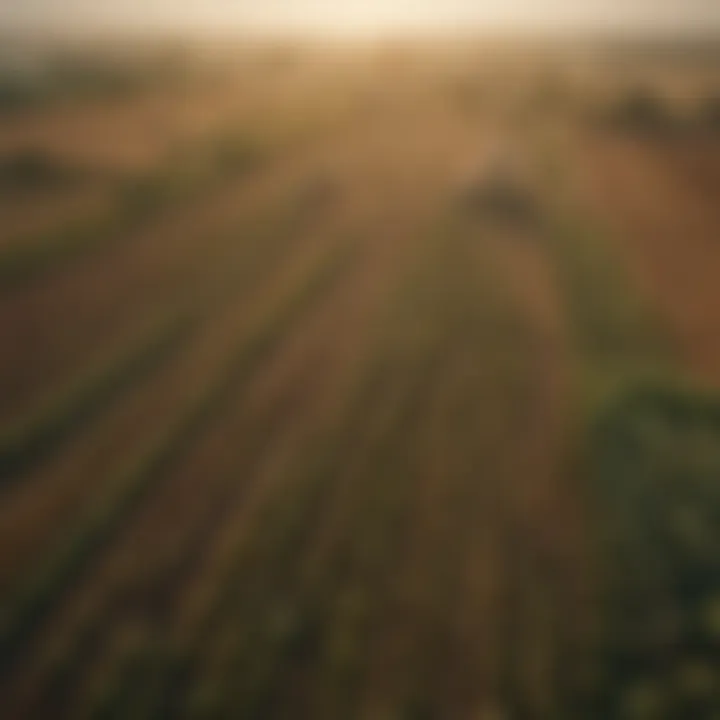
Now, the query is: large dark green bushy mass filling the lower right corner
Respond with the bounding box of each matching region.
[588,382,720,718]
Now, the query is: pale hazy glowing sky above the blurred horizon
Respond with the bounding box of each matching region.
[0,0,720,33]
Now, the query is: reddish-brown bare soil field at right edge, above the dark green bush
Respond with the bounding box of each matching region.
[575,132,720,385]
